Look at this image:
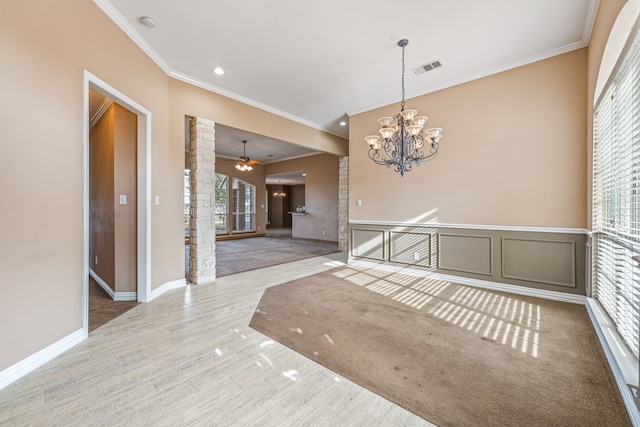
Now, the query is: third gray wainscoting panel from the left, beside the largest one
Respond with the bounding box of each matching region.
[438,233,493,276]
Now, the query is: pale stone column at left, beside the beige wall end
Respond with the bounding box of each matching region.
[189,117,216,284]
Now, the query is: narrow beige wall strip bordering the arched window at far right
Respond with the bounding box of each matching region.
[585,0,627,229]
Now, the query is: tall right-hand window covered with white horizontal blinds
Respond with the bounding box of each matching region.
[593,27,640,357]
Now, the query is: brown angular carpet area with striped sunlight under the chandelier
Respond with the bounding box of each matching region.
[250,266,631,427]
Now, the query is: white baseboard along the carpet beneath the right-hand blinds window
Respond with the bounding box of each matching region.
[586,298,640,427]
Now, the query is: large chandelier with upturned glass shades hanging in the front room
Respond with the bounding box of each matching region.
[365,39,442,176]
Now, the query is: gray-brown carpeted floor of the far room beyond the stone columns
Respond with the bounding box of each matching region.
[185,235,338,277]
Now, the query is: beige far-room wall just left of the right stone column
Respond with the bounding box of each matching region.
[264,154,338,242]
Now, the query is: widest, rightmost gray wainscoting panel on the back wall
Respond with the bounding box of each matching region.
[502,237,576,288]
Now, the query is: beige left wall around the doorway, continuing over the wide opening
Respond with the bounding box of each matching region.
[0,0,348,371]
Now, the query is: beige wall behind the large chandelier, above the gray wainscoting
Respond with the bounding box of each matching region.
[349,49,587,228]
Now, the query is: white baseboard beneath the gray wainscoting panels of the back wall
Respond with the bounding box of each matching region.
[349,258,586,305]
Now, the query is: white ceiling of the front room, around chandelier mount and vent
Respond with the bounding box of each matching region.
[94,0,598,140]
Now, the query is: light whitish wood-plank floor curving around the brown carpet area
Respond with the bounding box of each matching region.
[0,253,431,426]
